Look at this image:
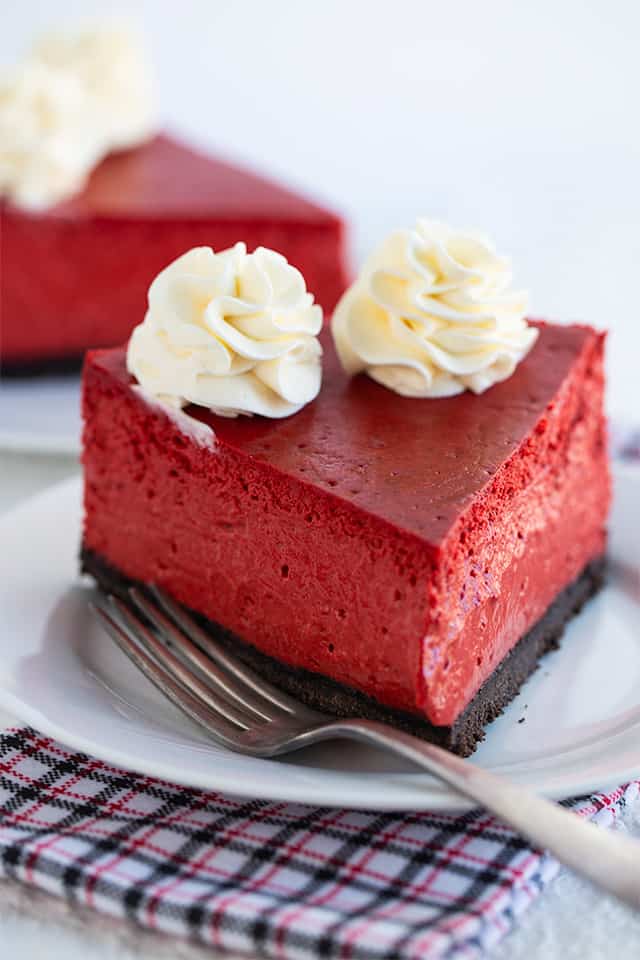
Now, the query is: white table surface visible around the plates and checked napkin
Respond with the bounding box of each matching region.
[0,453,640,960]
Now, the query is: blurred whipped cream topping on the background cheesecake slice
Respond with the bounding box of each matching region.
[0,27,155,210]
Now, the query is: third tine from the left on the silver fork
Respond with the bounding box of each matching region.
[129,587,282,720]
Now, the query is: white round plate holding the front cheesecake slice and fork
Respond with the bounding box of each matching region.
[0,468,640,810]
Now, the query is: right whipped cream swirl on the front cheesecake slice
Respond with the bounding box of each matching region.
[332,220,538,397]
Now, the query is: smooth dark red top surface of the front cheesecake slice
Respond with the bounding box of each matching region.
[148,323,594,545]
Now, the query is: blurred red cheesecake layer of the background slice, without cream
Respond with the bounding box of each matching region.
[0,137,346,364]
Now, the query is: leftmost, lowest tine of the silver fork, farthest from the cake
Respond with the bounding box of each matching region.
[89,601,243,750]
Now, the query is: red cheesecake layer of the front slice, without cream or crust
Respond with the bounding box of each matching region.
[84,324,610,725]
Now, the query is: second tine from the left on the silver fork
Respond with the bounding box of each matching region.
[108,595,252,730]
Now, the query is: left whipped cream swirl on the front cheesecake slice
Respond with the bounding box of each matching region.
[127,243,322,417]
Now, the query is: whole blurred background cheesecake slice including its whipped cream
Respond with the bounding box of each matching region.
[0,24,346,373]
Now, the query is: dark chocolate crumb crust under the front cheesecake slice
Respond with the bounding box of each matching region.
[81,547,606,757]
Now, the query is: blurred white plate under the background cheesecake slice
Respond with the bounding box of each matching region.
[0,374,80,454]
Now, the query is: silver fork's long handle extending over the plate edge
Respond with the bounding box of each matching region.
[323,720,640,909]
